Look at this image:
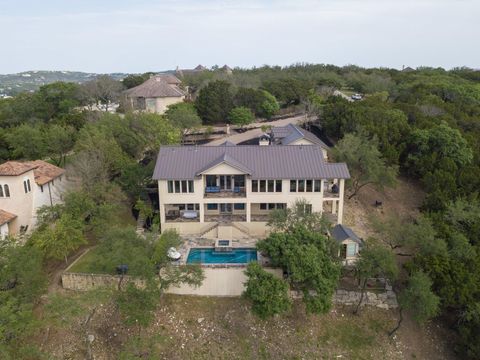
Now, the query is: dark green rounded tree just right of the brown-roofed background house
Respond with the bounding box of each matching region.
[195,80,233,124]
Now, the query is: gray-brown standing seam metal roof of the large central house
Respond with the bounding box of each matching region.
[153,145,350,180]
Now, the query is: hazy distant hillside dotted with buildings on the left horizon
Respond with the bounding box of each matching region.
[0,71,128,97]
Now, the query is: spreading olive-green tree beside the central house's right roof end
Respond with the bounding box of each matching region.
[333,133,398,199]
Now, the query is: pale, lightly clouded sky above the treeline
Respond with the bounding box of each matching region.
[0,0,480,74]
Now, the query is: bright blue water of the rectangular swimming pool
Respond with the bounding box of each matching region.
[187,247,257,264]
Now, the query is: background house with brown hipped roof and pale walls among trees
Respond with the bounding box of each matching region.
[124,74,187,114]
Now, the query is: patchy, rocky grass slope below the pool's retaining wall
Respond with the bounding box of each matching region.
[36,291,401,360]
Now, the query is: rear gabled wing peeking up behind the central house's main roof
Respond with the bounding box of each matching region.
[259,124,329,159]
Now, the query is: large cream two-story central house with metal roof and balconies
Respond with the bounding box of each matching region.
[153,142,350,236]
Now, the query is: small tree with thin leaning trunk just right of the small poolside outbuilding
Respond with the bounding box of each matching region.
[353,245,398,314]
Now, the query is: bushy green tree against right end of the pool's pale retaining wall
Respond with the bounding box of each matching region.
[243,262,292,319]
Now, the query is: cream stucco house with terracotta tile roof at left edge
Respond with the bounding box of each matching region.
[0,160,66,239]
